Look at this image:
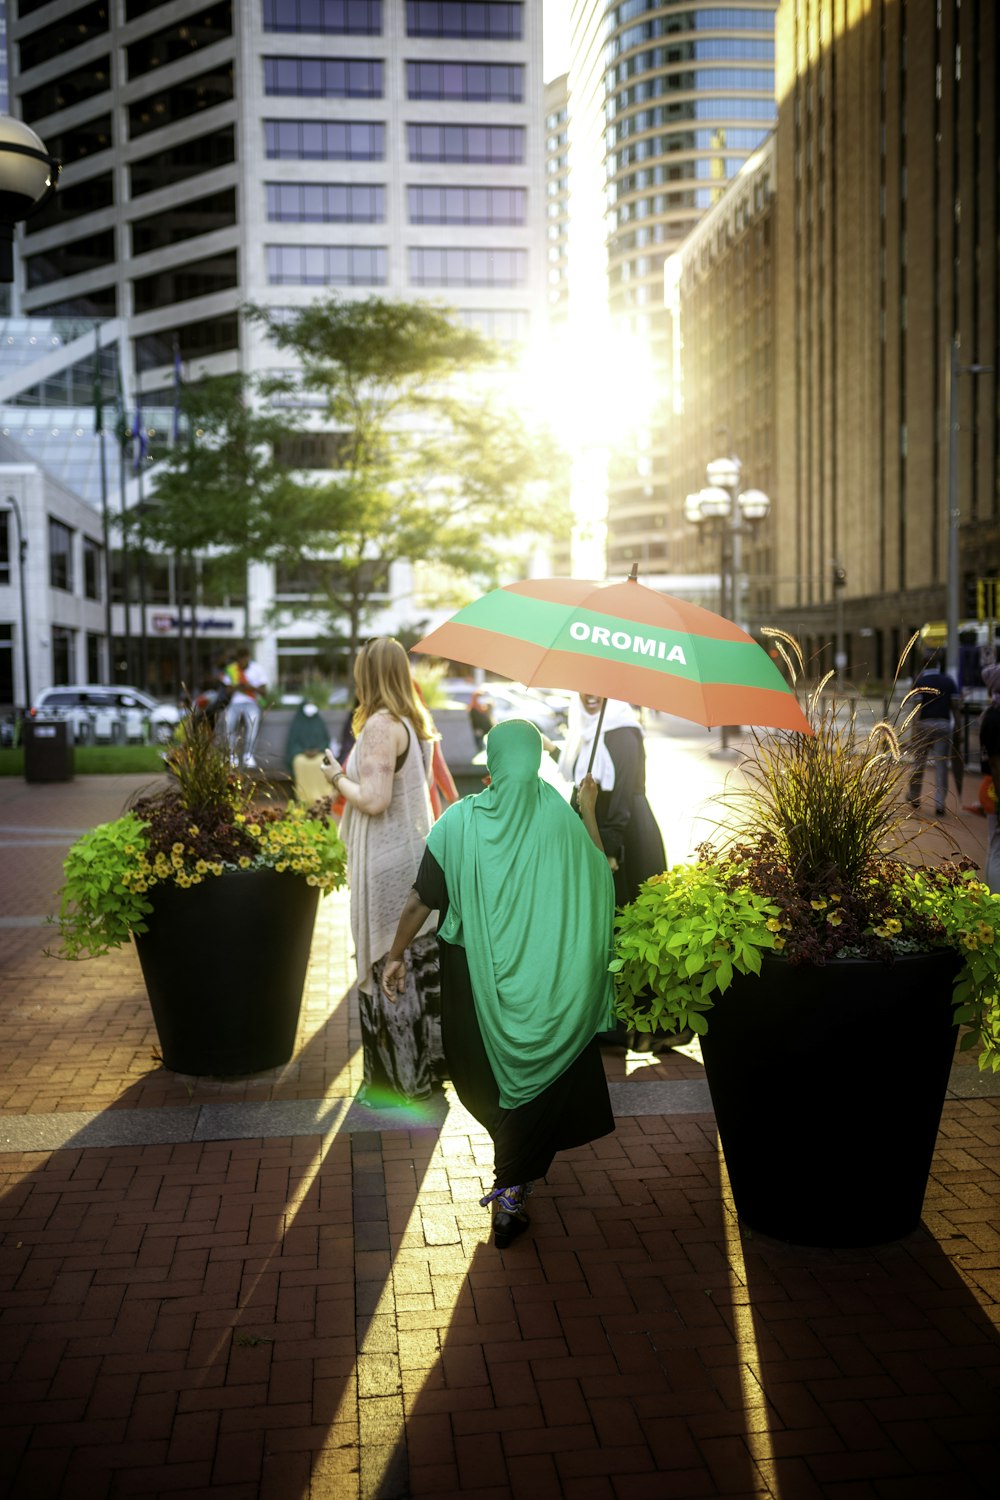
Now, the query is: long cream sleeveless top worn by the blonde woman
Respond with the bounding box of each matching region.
[340,719,435,995]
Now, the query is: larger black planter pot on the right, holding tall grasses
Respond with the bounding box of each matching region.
[702,950,960,1247]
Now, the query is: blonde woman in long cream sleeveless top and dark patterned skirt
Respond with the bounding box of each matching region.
[324,636,445,1104]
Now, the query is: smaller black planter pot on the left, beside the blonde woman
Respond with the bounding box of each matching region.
[135,870,319,1077]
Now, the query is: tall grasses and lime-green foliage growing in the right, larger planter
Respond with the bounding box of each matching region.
[612,632,1000,1073]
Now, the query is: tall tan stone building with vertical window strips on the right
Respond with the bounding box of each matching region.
[670,0,1000,680]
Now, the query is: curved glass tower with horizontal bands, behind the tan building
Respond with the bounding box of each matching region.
[570,0,778,576]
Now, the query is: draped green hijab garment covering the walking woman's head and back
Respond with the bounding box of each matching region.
[418,720,615,1110]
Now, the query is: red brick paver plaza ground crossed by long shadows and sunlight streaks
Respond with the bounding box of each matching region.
[0,768,1000,1500]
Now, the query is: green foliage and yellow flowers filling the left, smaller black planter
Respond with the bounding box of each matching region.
[55,716,346,959]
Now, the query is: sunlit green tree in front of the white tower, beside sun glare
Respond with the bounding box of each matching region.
[249,297,568,654]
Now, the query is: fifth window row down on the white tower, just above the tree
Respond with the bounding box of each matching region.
[267,245,528,287]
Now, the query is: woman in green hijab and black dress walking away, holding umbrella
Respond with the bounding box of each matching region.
[382,719,615,1248]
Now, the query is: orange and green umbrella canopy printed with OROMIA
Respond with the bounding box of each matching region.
[412,578,813,734]
